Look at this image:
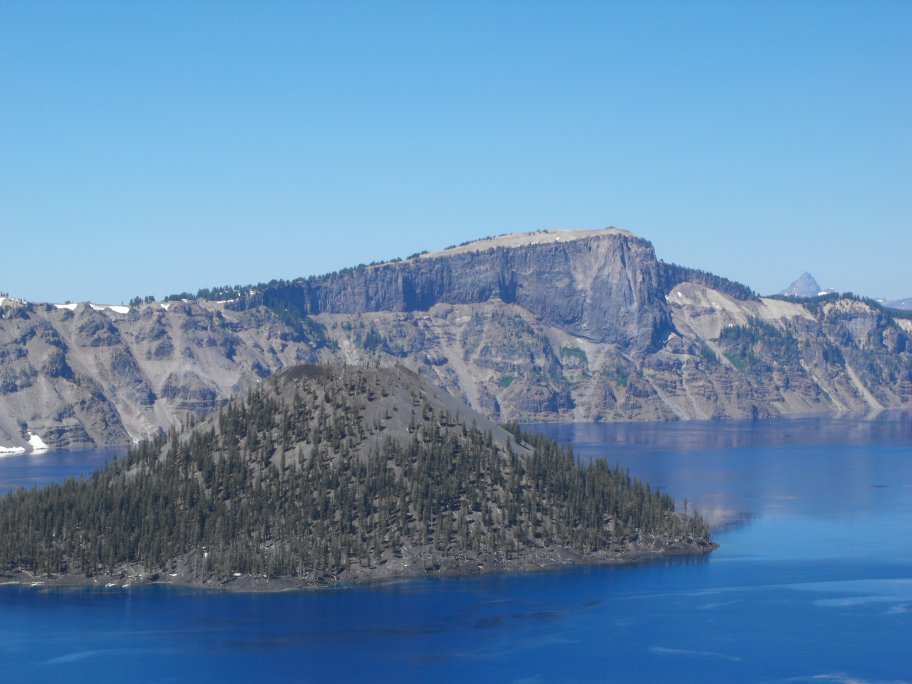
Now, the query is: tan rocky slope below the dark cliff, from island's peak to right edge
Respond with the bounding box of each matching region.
[318,290,912,421]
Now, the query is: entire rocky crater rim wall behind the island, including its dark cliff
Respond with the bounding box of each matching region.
[0,230,912,449]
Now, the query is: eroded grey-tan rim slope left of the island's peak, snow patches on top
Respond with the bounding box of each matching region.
[0,302,319,447]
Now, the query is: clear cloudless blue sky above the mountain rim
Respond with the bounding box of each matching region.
[0,0,912,303]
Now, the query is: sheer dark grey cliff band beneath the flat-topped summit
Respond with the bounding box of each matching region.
[243,230,671,350]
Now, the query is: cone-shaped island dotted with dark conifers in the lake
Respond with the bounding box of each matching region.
[0,366,716,590]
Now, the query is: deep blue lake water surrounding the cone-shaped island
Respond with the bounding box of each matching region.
[0,414,912,682]
